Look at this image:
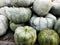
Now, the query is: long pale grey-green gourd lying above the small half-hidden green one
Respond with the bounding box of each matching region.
[0,7,31,23]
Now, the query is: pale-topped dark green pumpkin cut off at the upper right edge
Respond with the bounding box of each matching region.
[50,2,60,16]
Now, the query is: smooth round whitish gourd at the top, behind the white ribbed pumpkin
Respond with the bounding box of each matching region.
[33,0,52,16]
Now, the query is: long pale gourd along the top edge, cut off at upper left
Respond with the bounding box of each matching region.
[0,0,34,7]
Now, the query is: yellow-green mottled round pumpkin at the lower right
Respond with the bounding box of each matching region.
[38,29,59,45]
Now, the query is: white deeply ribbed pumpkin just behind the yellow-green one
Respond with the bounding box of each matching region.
[30,14,56,31]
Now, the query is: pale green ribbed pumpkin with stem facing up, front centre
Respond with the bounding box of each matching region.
[14,26,36,45]
